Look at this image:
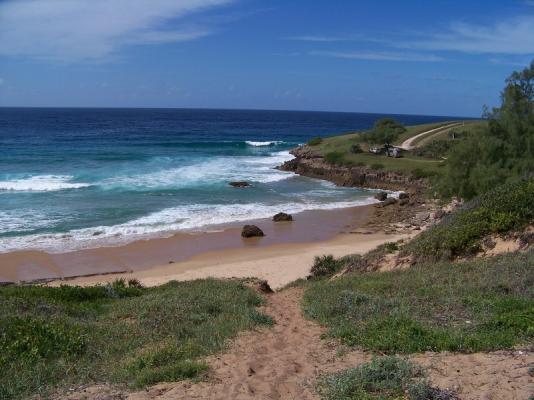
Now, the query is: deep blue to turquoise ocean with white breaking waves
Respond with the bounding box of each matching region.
[0,108,452,252]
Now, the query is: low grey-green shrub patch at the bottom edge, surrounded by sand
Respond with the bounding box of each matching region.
[317,356,456,400]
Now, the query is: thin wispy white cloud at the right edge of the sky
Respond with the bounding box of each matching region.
[412,16,534,55]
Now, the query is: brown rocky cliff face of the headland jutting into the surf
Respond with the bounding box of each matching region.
[280,146,428,191]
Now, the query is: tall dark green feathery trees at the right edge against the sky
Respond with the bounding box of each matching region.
[438,62,534,199]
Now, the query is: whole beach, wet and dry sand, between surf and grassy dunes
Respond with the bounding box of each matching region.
[0,206,402,286]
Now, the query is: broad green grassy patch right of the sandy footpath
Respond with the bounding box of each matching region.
[303,251,534,353]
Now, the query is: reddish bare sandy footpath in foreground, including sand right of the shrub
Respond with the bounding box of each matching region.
[63,288,534,400]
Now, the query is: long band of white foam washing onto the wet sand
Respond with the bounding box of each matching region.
[0,197,376,252]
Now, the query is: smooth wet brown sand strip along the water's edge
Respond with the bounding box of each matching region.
[0,205,394,284]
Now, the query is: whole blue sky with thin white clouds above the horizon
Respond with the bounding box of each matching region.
[0,0,534,116]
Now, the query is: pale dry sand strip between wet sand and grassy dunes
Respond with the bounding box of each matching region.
[49,233,407,289]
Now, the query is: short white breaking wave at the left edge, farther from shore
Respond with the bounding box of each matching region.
[0,175,91,192]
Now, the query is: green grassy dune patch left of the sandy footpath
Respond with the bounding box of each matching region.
[0,280,272,399]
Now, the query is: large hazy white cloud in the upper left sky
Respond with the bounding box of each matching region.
[0,0,233,61]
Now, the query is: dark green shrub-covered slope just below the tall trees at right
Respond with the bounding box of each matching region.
[402,179,534,261]
